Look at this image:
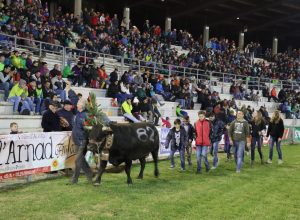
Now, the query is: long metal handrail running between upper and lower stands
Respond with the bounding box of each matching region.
[0,32,299,91]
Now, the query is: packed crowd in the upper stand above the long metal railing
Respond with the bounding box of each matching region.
[0,1,300,83]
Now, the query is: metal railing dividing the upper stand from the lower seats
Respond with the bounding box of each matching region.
[0,33,299,91]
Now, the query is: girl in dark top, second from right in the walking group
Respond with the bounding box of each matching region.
[250,111,266,166]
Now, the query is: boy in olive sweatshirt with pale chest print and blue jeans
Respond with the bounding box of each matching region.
[229,110,249,173]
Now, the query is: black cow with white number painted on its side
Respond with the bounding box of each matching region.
[88,123,159,185]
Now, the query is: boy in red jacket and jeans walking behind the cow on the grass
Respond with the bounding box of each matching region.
[195,111,211,174]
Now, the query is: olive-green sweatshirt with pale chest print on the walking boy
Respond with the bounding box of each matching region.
[229,119,250,141]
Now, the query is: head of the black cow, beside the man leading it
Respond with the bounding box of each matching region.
[87,124,111,153]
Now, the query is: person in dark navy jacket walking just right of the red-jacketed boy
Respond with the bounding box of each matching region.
[210,113,225,170]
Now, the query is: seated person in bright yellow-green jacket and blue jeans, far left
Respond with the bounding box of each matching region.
[7,79,33,113]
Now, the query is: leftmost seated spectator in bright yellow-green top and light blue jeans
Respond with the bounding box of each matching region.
[7,79,28,113]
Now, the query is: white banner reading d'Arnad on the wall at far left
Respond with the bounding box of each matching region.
[0,132,75,180]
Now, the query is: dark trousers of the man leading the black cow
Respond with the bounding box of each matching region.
[72,141,93,183]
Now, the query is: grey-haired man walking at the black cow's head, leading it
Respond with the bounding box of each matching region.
[71,100,93,184]
